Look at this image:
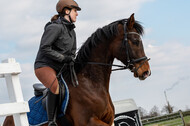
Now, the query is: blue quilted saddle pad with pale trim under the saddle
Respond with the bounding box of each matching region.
[27,76,69,126]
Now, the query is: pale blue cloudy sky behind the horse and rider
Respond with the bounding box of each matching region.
[0,0,190,123]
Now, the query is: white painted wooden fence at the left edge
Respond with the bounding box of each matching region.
[0,58,29,126]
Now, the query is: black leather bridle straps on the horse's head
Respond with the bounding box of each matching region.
[122,21,150,73]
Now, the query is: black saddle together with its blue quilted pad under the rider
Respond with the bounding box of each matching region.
[27,76,69,126]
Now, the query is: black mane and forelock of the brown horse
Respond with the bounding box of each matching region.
[75,19,143,73]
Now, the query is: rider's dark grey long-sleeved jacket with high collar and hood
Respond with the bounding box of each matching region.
[34,17,76,72]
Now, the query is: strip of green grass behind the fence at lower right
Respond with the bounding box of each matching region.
[144,116,190,126]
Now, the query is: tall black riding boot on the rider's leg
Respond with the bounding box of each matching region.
[46,90,59,126]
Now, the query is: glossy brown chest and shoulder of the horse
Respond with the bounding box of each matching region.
[70,79,114,124]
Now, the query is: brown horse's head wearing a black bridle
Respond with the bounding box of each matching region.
[112,14,151,80]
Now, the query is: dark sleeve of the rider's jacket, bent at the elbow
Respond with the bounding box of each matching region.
[40,24,64,62]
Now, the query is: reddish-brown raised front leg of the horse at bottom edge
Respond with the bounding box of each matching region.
[87,117,114,126]
